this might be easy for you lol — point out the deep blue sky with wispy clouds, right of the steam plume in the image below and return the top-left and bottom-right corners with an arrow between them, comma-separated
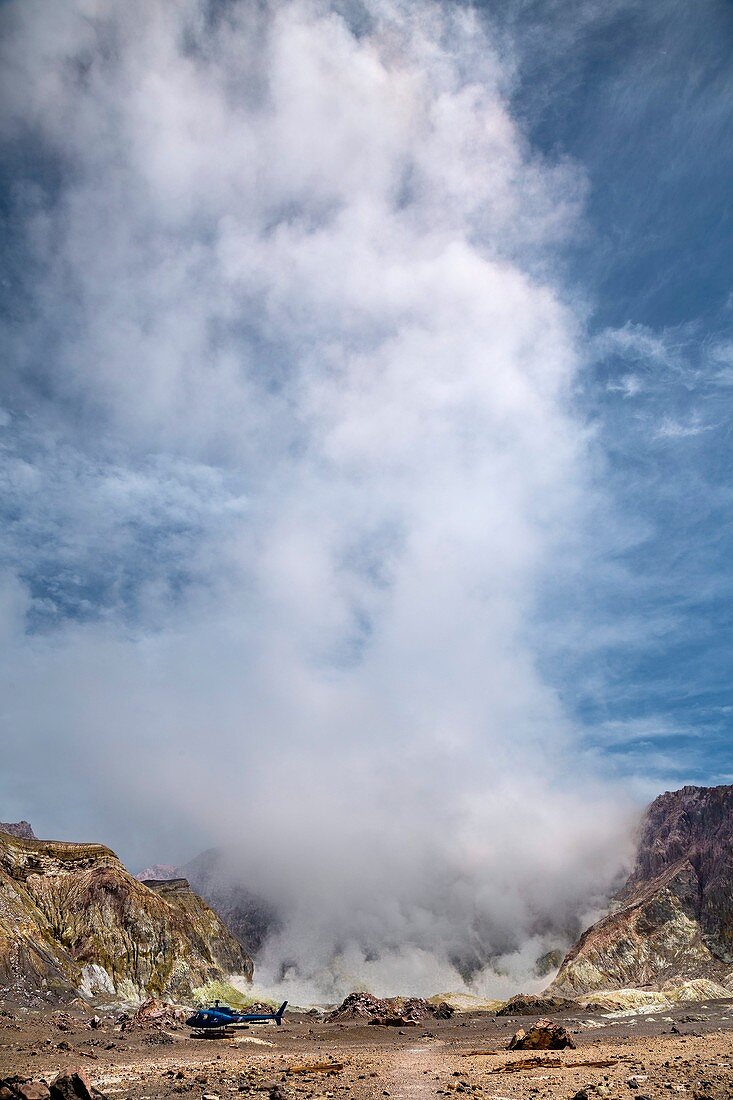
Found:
484,2 -> 733,782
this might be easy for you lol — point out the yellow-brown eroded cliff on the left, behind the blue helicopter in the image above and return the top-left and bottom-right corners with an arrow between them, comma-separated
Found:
0,834 -> 252,1000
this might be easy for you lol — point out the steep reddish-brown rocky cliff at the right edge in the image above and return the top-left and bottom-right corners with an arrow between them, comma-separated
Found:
549,787 -> 733,997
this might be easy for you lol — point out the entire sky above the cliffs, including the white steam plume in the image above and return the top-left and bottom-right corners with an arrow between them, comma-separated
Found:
0,0 -> 733,994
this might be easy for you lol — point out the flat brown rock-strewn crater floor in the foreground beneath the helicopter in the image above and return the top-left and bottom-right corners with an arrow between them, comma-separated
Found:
0,1001 -> 733,1100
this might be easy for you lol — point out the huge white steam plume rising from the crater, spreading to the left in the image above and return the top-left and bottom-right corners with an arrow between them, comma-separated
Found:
2,0 -> 626,997
